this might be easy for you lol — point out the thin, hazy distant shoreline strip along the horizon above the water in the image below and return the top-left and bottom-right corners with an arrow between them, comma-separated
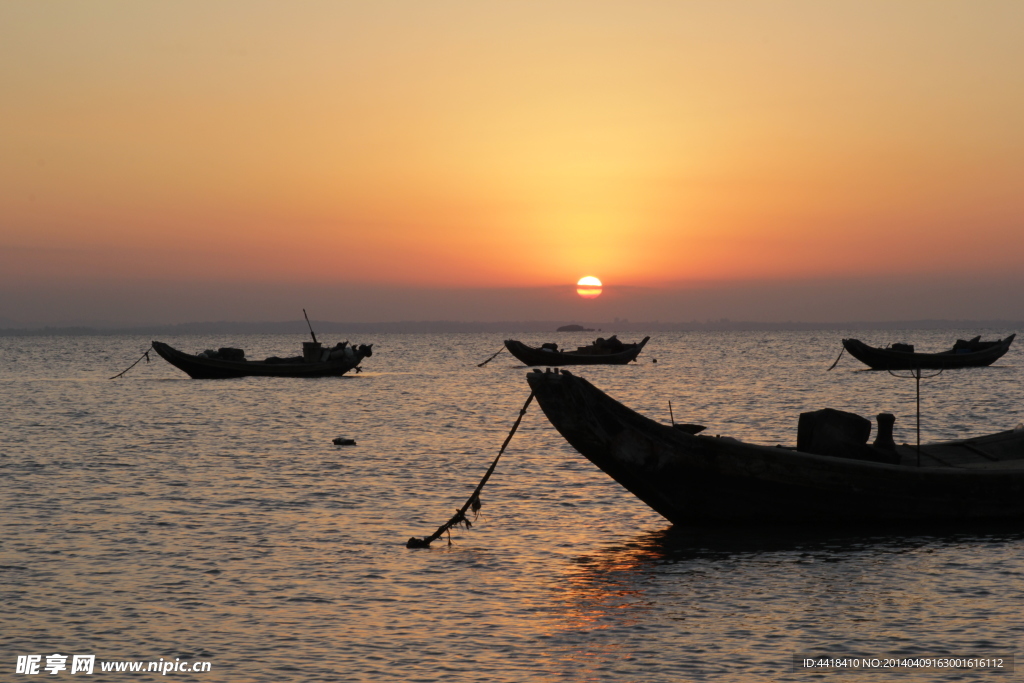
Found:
0,319 -> 1024,337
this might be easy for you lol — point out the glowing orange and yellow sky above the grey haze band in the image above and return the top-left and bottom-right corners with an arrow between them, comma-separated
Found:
0,0 -> 1024,323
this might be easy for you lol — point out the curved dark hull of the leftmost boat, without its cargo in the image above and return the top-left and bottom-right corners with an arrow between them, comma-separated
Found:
153,341 -> 366,380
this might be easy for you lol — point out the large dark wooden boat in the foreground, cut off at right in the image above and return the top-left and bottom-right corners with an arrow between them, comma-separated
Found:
527,370 -> 1024,524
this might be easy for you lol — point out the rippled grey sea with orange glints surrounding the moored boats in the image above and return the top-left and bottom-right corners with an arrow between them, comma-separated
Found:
0,330 -> 1024,682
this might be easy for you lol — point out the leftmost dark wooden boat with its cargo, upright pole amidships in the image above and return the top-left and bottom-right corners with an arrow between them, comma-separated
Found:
153,341 -> 373,380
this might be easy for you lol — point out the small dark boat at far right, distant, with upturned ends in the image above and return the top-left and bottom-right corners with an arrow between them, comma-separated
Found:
843,334 -> 1017,370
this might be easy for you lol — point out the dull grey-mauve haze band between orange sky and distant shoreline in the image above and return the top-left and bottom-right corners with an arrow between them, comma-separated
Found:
0,280 -> 1024,329
